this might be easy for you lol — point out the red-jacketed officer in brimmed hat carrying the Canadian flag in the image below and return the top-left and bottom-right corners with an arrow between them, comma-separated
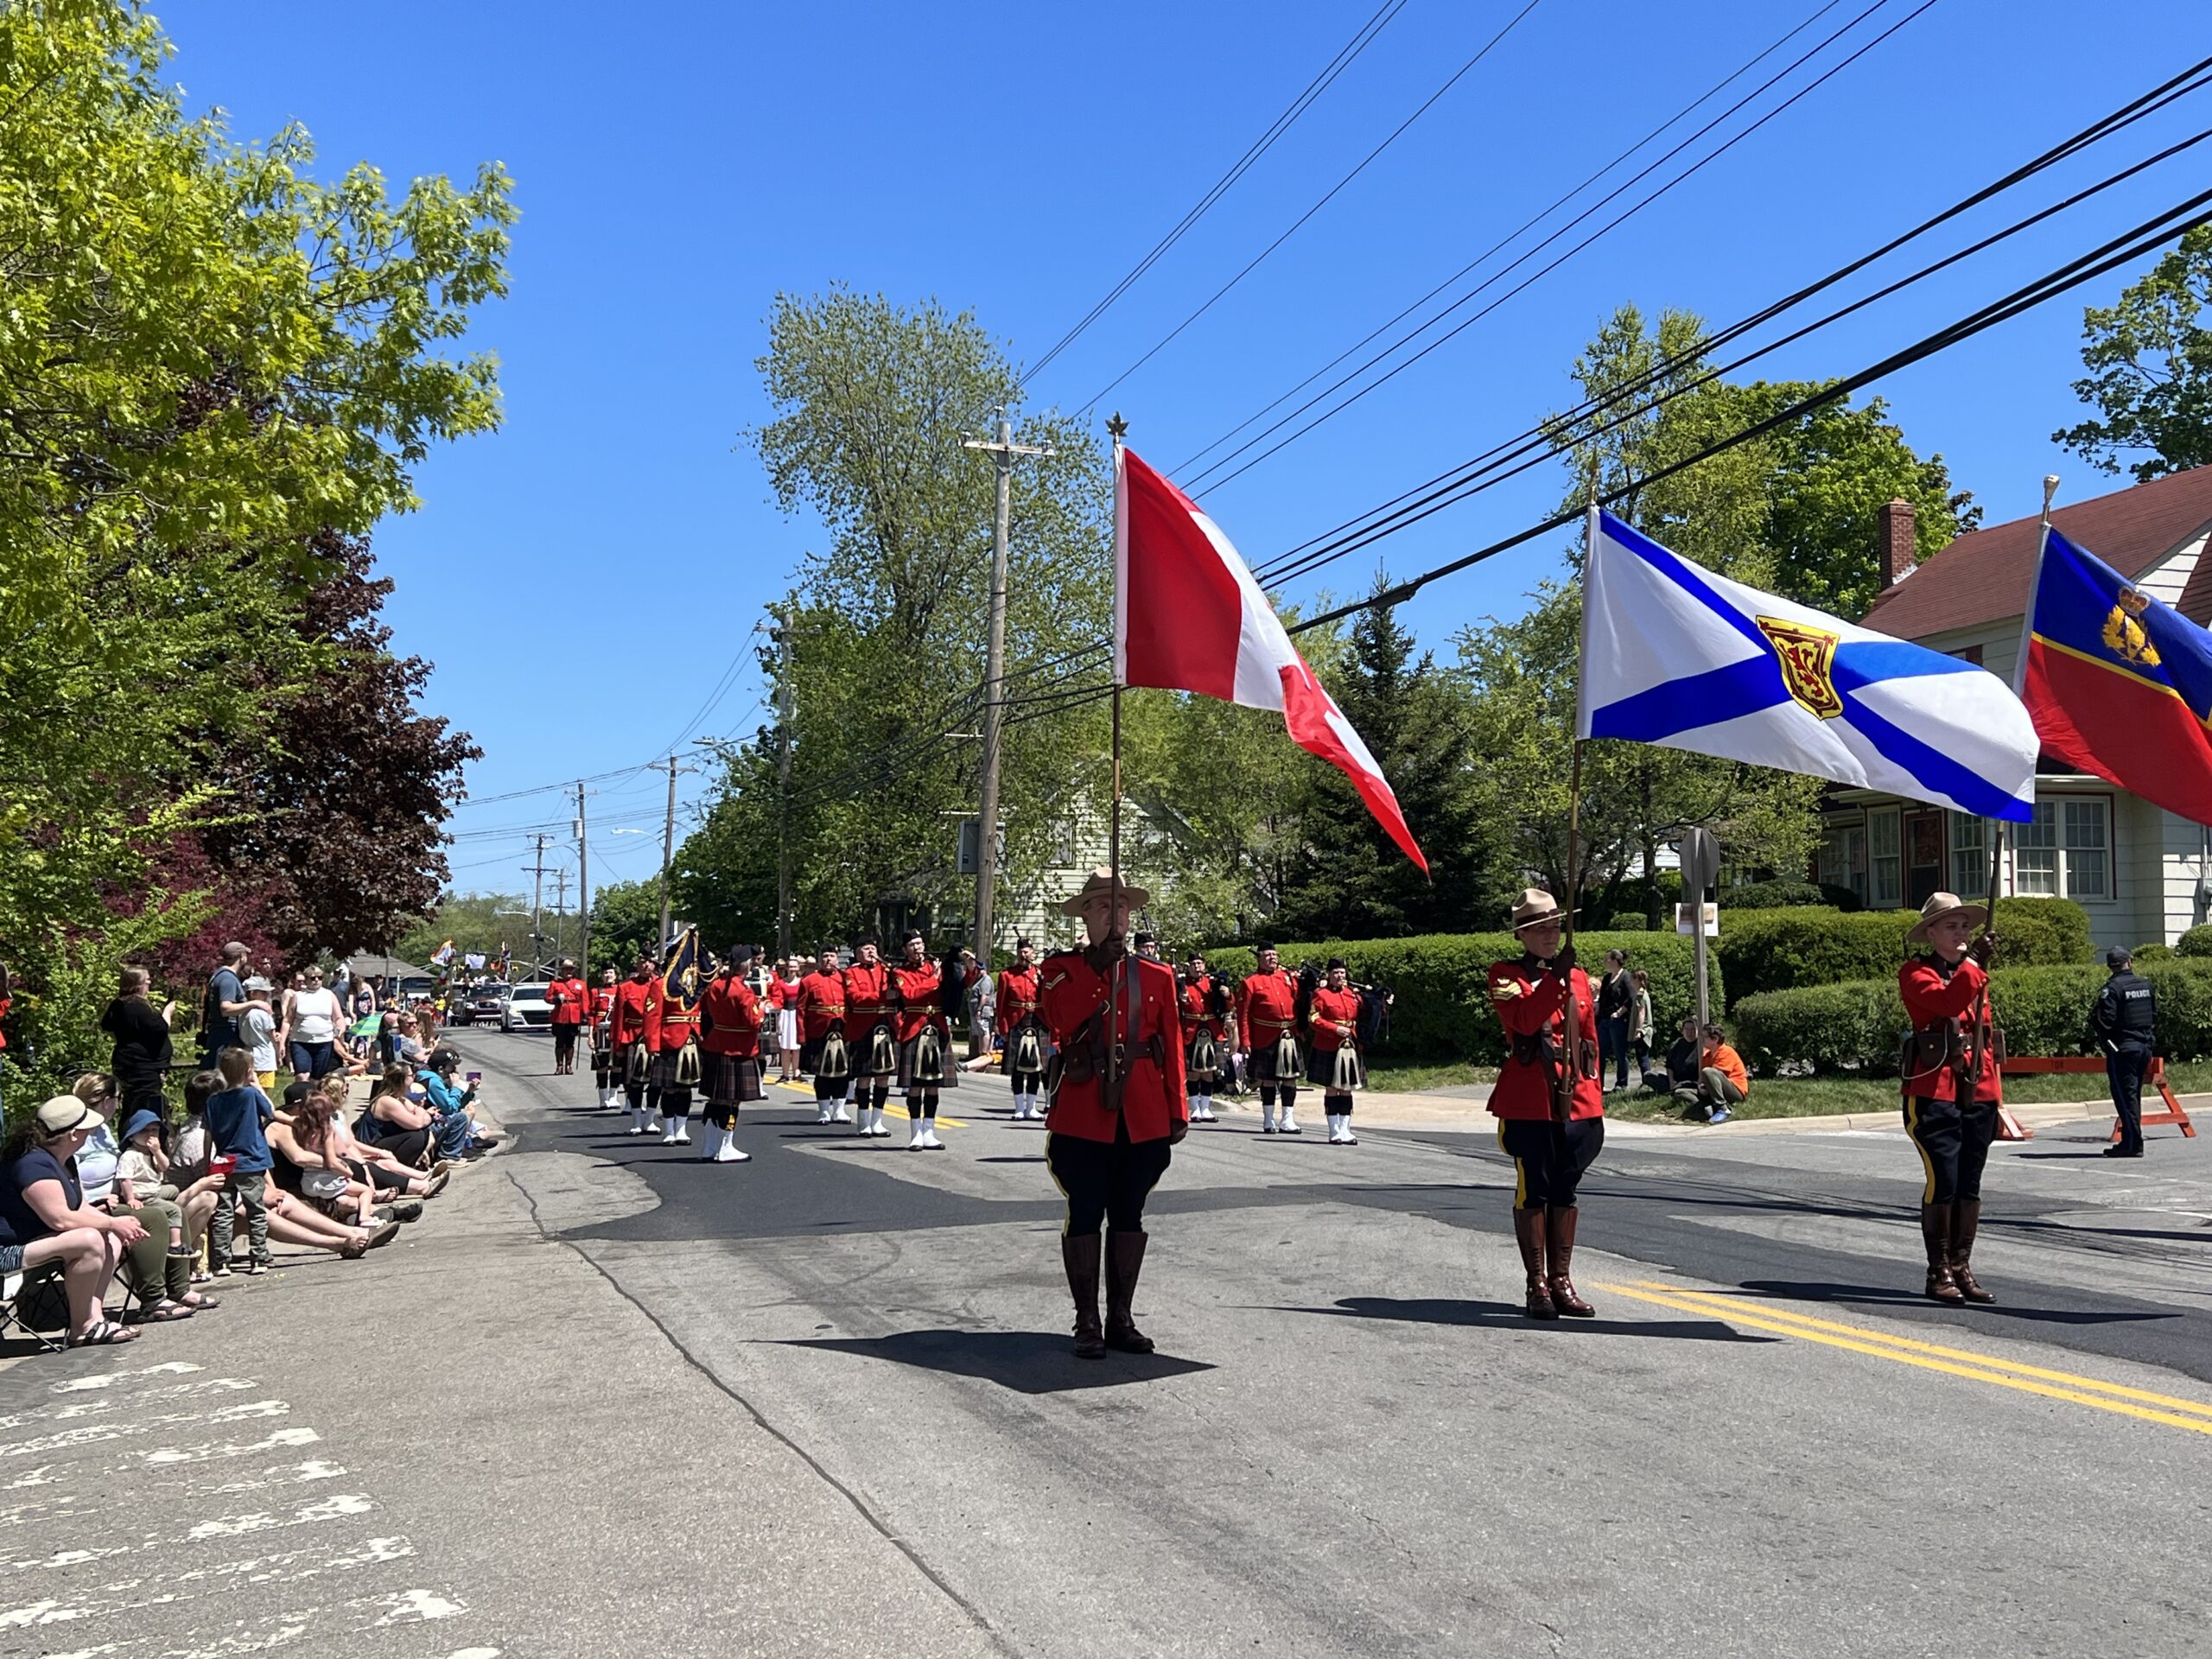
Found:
1038,869 -> 1190,1360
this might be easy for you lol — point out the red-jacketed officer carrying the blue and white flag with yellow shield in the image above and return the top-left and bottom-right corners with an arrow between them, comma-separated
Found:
1491,887 -> 1606,1319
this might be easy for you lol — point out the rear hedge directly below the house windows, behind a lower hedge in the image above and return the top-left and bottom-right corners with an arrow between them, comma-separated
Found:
1717,898 -> 2090,1002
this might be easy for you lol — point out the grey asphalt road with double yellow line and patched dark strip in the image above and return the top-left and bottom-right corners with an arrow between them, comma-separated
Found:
17,1033 -> 2212,1659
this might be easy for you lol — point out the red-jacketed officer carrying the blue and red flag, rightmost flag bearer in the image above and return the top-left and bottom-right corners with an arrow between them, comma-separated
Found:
1897,893 -> 2004,1305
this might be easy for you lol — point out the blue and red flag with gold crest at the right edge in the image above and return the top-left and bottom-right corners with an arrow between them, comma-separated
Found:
2018,529 -> 2212,823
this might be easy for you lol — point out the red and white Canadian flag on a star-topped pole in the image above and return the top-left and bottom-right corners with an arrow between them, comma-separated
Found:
1113,449 -> 1429,874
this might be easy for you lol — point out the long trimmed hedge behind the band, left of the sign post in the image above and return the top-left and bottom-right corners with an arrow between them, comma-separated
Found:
1205,931 -> 1723,1066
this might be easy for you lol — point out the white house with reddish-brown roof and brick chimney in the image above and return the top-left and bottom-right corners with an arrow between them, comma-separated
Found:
1814,467 -> 2212,944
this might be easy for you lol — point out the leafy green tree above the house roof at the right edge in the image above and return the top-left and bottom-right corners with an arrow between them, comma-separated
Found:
2050,226 -> 2212,485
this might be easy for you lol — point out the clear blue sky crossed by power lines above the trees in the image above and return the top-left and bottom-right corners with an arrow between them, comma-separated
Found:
157,0 -> 2212,892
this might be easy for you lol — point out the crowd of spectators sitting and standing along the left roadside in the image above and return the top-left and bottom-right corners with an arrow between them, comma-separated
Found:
0,944 -> 498,1347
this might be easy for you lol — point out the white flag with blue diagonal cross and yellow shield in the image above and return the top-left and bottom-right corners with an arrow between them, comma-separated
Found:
1577,509 -> 2037,823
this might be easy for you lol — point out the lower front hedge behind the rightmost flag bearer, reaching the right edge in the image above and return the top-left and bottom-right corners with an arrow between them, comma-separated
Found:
1734,960 -> 2212,1077
